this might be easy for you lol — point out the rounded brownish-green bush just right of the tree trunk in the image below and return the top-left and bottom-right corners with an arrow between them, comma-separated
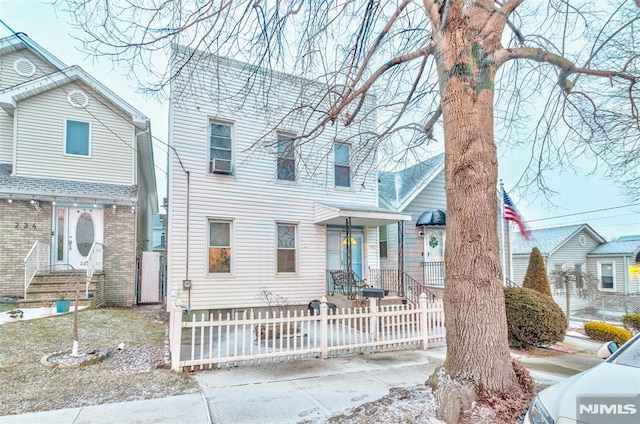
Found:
504,287 -> 567,348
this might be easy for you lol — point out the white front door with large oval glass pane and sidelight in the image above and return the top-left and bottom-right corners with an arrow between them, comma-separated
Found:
52,206 -> 103,269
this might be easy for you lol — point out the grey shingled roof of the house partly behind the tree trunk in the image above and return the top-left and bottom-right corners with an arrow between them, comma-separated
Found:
378,153 -> 444,210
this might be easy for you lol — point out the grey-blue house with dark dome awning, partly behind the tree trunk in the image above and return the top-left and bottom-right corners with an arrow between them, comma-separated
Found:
378,154 -> 518,286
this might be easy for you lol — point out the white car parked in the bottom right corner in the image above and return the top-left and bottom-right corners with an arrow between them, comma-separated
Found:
524,334 -> 640,424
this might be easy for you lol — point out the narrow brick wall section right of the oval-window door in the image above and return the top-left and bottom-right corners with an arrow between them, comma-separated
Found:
102,207 -> 136,306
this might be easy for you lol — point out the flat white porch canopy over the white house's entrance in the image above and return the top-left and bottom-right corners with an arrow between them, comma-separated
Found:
315,203 -> 411,227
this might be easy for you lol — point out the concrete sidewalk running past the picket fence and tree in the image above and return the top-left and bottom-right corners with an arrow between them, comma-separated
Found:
0,337 -> 602,424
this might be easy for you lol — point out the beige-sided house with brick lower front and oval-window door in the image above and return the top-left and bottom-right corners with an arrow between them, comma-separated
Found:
0,34 -> 158,306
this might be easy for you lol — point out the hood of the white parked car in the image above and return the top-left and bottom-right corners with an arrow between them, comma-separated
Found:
538,362 -> 640,419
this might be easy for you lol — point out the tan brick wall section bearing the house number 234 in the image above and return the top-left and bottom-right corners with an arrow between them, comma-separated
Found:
0,199 -> 52,297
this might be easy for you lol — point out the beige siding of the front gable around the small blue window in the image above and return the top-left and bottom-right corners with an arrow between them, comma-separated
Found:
14,84 -> 135,184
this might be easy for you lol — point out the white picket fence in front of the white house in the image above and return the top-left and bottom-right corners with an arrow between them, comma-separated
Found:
170,294 -> 445,371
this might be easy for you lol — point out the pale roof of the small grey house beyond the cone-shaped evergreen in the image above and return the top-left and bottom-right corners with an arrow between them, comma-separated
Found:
511,224 -> 605,256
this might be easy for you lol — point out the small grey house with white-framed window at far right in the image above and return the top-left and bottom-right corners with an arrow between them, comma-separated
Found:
512,224 -> 640,309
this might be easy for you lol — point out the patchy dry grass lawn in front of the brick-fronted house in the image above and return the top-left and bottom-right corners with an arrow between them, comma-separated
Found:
0,305 -> 197,415
